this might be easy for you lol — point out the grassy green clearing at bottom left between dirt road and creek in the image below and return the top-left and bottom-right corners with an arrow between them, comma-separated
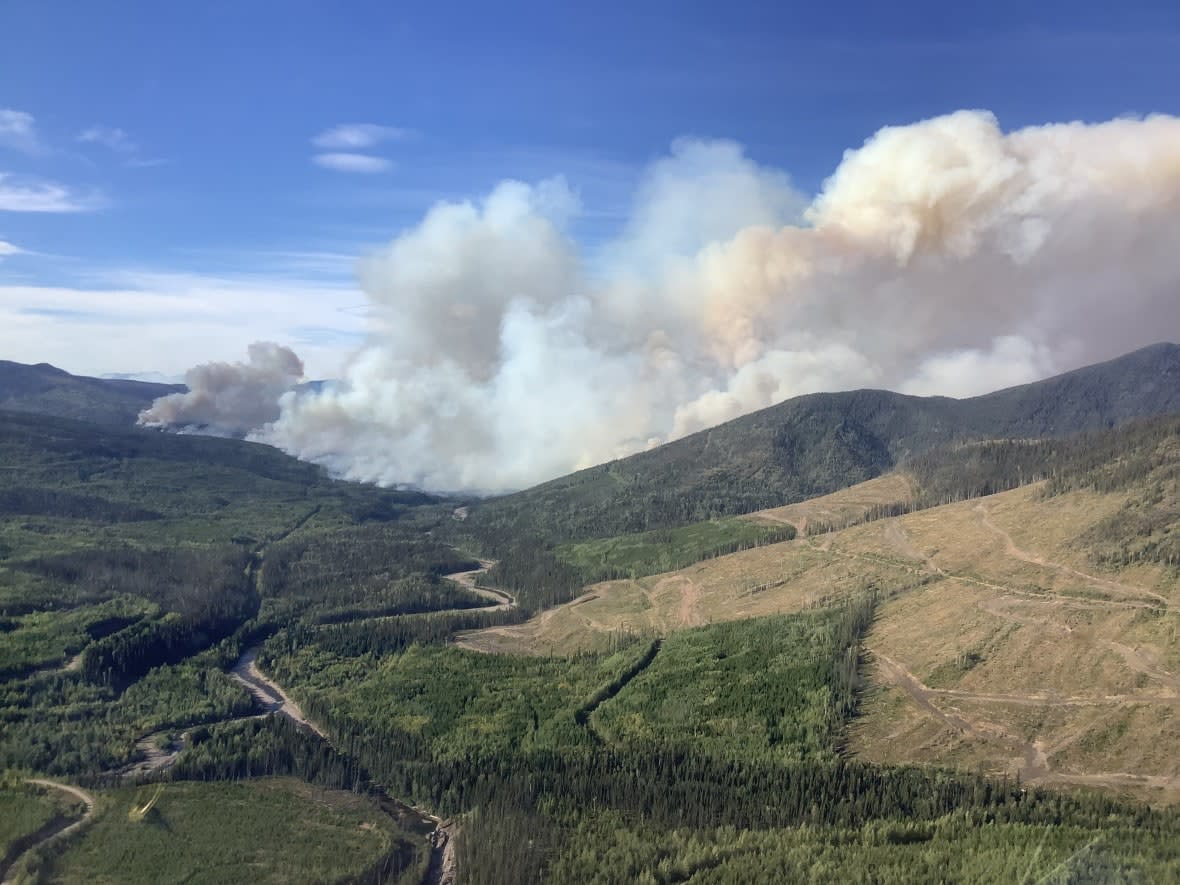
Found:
44,780 -> 425,885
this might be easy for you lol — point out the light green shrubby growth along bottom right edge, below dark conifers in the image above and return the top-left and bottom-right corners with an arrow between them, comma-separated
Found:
548,812 -> 1180,885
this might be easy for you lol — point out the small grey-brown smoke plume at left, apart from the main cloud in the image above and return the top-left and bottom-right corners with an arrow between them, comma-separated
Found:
139,341 -> 303,437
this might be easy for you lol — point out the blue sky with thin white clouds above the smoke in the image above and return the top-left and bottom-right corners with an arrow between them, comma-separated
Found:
0,0 -> 1180,374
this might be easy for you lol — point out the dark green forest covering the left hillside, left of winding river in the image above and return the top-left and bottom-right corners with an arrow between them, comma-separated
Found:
0,413 -> 469,778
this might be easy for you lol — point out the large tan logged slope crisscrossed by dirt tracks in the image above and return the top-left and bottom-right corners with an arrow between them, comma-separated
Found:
463,480 -> 1180,801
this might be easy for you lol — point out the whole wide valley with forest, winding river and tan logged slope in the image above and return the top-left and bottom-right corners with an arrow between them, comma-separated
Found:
0,349 -> 1180,885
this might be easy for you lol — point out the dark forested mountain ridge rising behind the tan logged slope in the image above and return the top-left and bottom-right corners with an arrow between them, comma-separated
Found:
467,343 -> 1180,545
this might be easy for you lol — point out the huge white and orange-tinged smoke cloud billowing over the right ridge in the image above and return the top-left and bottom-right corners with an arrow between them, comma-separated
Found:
153,111 -> 1180,491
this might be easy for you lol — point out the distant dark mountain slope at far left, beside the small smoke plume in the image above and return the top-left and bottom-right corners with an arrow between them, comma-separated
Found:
0,360 -> 185,427
